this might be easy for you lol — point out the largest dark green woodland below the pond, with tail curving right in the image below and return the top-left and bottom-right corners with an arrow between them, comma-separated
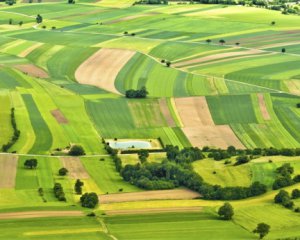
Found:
120,145 -> 267,200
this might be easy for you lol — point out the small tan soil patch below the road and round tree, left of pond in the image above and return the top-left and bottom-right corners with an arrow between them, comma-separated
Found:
60,157 -> 90,179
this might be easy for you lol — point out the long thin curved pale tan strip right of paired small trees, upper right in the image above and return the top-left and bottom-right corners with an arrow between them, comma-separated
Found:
173,49 -> 263,67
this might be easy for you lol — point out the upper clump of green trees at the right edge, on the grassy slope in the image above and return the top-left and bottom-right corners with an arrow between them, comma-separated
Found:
272,163 -> 300,190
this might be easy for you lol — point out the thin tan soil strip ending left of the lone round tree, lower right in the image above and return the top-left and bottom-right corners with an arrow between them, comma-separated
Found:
105,207 -> 202,215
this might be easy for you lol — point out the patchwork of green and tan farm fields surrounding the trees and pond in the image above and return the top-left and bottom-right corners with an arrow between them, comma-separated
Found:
0,0 -> 300,240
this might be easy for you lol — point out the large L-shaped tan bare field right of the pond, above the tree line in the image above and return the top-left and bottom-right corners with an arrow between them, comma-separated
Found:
175,97 -> 245,149
